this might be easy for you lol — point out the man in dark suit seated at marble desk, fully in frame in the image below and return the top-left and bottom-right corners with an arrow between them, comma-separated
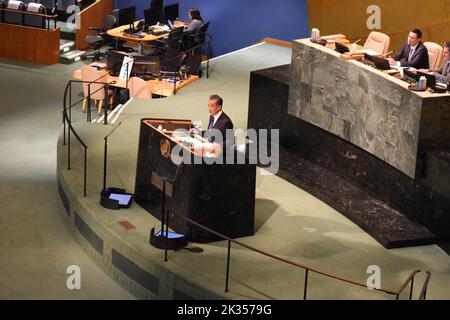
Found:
389,29 -> 430,69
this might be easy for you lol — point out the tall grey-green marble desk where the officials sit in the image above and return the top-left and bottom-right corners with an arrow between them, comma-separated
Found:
288,39 -> 450,179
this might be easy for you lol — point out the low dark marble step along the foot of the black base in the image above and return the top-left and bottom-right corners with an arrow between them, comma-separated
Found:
277,147 -> 437,249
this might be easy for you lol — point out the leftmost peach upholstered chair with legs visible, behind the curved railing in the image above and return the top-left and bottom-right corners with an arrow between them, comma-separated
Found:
81,66 -> 113,114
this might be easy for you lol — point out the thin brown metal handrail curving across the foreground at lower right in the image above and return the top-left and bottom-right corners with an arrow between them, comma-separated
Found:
166,213 -> 421,300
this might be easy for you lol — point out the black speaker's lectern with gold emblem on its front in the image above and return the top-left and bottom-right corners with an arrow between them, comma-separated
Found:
134,119 -> 256,242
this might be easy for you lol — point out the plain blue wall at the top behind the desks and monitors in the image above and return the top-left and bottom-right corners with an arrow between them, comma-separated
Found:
116,0 -> 309,56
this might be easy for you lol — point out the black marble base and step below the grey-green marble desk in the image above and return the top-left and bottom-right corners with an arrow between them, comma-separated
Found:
248,65 -> 450,248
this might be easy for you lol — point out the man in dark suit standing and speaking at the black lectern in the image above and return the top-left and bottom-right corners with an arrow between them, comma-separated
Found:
191,94 -> 233,146
